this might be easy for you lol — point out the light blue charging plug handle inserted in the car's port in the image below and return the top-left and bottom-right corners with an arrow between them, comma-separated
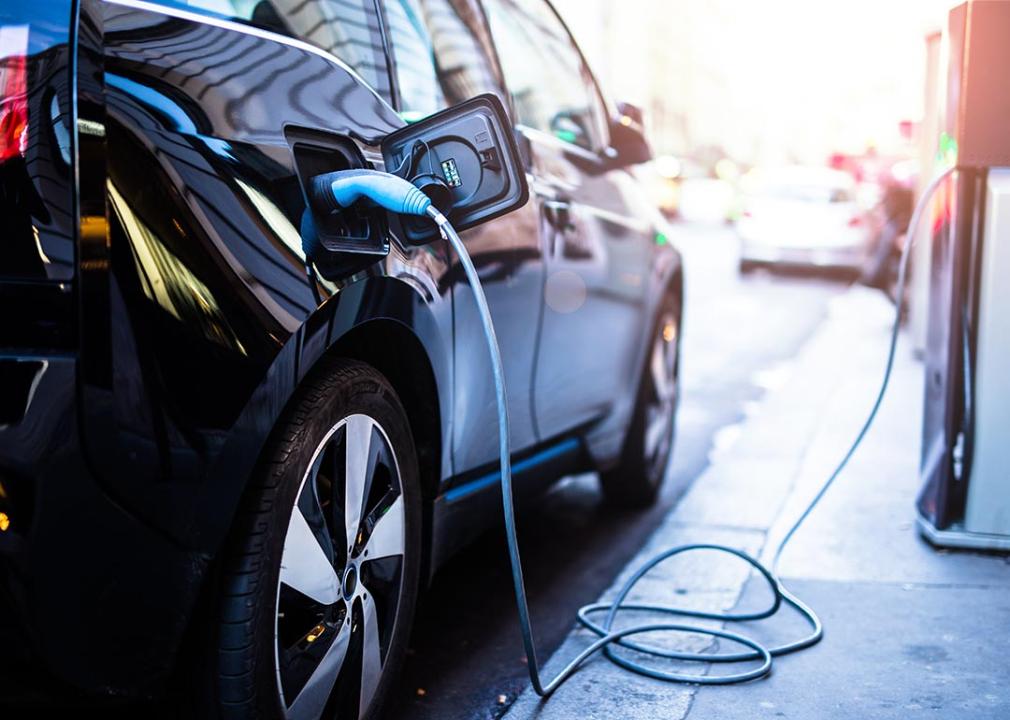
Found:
309,170 -> 431,215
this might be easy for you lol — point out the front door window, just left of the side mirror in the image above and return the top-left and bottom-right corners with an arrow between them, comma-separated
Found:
484,0 -> 605,149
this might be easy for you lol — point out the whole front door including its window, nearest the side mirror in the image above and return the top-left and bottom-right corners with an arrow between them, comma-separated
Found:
484,0 -> 654,456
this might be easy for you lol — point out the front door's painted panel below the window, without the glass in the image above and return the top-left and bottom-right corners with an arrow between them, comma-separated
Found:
524,129 -> 655,458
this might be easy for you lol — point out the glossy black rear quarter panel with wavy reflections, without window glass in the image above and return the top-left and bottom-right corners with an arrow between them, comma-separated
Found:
85,4 -> 446,548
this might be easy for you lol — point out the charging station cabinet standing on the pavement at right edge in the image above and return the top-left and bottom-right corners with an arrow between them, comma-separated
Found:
917,0 -> 1010,550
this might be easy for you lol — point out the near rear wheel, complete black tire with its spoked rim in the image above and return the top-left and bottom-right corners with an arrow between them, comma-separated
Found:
208,359 -> 421,720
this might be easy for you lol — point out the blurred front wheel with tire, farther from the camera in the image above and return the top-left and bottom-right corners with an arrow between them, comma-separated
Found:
600,294 -> 681,508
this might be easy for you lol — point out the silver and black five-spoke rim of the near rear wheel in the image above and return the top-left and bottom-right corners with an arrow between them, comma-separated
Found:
275,414 -> 405,720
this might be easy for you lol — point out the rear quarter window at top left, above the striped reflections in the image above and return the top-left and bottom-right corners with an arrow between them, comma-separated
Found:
160,0 -> 392,102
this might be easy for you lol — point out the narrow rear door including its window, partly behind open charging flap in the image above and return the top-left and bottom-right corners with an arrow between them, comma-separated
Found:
377,0 -> 544,482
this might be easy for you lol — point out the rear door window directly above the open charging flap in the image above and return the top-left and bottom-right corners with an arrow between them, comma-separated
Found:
384,0 -> 504,120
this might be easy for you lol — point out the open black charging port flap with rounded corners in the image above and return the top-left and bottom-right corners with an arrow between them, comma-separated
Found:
382,94 -> 529,245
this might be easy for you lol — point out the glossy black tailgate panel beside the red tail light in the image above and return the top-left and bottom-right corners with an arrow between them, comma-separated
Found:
0,0 -> 77,355
